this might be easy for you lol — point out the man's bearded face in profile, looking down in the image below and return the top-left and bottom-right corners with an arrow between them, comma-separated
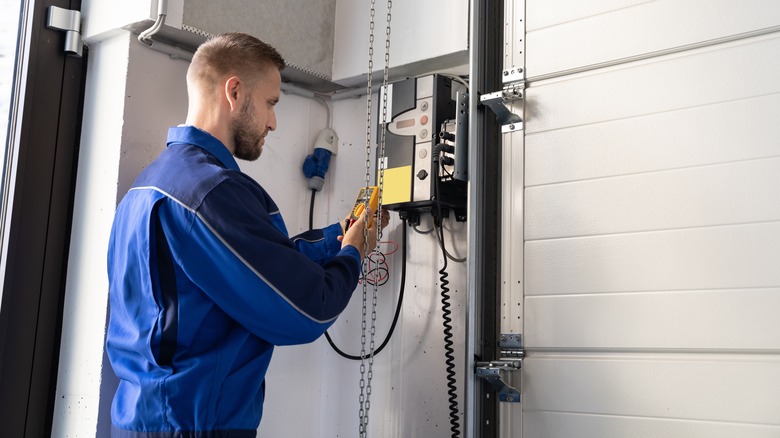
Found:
232,68 -> 282,161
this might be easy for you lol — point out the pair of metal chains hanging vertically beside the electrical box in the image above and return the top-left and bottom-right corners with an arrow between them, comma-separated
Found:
359,0 -> 393,438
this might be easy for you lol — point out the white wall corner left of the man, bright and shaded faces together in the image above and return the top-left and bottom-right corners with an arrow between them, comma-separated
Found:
54,31 -> 192,436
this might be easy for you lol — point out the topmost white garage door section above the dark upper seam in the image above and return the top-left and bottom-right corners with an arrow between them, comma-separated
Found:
526,0 -> 780,80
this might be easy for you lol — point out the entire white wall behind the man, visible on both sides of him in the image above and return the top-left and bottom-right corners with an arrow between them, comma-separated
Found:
53,1 -> 466,437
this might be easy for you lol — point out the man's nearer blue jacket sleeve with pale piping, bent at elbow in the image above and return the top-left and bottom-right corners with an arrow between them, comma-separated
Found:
160,180 -> 360,345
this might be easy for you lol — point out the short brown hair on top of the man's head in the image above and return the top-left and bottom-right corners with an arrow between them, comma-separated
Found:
187,32 -> 285,91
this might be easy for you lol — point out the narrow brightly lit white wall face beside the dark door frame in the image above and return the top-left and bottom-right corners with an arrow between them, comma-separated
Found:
52,35 -> 129,436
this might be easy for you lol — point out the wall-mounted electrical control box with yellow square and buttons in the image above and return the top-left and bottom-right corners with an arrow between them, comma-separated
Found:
377,75 -> 468,220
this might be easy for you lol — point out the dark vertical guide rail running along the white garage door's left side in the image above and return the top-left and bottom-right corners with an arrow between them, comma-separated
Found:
464,0 -> 502,437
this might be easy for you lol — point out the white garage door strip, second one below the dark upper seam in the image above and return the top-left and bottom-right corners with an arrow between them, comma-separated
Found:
525,93 -> 780,187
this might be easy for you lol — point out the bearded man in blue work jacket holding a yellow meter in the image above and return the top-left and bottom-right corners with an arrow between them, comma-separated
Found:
106,33 -> 386,438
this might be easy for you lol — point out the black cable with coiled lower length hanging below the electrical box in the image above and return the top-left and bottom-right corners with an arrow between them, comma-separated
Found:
431,144 -> 460,438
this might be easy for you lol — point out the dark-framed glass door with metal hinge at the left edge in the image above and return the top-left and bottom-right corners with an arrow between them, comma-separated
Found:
0,0 -> 87,437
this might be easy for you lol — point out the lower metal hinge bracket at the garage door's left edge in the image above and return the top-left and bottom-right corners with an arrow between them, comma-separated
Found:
475,333 -> 525,403
